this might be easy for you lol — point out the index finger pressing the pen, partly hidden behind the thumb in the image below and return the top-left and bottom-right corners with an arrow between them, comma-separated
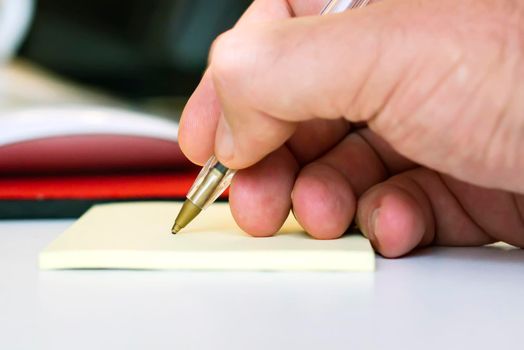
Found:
178,0 -> 327,164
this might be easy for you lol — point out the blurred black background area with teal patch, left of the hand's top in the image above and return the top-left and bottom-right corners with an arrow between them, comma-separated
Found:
20,0 -> 251,98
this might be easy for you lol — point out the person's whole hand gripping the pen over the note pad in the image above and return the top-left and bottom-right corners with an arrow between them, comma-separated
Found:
179,0 -> 524,257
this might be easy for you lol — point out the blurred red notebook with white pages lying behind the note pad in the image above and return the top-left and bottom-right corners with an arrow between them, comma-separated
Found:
0,107 -> 209,219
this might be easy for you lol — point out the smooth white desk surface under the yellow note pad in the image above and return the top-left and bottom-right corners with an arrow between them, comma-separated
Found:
0,220 -> 524,350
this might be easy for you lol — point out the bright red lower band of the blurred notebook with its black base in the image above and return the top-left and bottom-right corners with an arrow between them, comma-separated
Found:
0,171 -> 207,219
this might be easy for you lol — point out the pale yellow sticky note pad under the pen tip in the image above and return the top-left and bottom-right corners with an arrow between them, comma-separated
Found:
39,202 -> 375,271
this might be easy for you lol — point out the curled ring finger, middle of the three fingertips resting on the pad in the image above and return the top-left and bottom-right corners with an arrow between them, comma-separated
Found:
292,129 -> 412,239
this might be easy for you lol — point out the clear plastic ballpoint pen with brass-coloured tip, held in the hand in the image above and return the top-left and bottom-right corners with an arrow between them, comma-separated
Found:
171,0 -> 372,234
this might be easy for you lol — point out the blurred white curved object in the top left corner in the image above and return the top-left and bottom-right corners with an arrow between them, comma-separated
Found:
0,0 -> 34,63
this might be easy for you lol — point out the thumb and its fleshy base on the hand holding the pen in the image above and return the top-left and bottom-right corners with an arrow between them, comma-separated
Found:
210,0 -> 524,191
